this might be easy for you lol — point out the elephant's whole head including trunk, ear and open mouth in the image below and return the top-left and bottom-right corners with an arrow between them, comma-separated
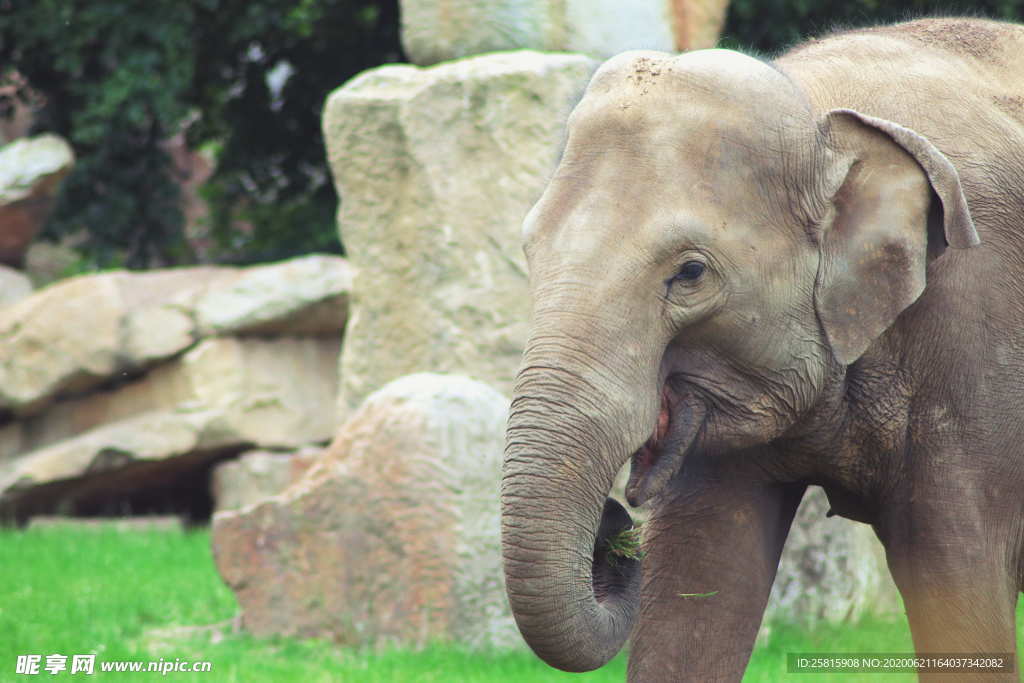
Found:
502,50 -> 978,671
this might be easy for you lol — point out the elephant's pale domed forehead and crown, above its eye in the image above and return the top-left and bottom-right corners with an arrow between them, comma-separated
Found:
523,50 -> 816,258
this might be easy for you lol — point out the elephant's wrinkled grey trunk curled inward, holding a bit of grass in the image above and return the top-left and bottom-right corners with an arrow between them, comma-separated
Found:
502,335 -> 657,672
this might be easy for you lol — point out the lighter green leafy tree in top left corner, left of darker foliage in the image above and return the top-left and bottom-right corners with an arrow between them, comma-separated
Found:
0,0 -> 194,265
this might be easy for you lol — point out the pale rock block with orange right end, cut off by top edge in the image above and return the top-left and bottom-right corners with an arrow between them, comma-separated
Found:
401,0 -> 728,65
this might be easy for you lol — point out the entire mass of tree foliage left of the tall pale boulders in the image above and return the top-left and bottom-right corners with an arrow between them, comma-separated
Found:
0,0 -> 400,267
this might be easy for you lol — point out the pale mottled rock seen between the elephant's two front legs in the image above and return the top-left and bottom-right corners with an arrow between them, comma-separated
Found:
764,486 -> 902,626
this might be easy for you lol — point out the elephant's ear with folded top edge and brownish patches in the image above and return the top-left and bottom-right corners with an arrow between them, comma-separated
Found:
814,110 -> 980,365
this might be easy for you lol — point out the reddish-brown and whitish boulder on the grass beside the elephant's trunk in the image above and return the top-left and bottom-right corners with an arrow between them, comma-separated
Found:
213,374 -> 521,647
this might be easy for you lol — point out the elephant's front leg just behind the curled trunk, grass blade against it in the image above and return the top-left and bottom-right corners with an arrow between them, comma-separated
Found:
629,462 -> 805,682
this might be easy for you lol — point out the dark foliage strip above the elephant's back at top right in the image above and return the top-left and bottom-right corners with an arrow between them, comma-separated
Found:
723,0 -> 1024,54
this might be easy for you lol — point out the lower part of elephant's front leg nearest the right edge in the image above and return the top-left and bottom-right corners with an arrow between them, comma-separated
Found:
879,490 -> 1019,681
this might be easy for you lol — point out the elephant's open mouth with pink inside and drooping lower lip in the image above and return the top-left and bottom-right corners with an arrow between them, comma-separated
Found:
626,383 -> 707,507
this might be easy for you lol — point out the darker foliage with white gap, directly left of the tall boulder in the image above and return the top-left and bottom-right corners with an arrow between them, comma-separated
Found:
188,0 -> 402,260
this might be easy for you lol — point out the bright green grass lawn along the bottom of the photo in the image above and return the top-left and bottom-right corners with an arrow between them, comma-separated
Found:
0,527 -> 1022,683
